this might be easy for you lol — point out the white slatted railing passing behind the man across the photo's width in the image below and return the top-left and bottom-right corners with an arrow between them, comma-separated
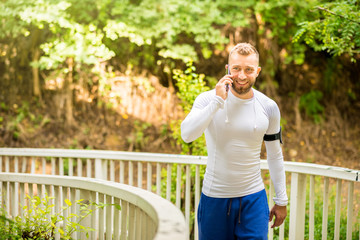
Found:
0,148 -> 360,240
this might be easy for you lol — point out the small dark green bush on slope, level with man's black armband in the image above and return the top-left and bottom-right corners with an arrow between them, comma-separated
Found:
299,90 -> 324,123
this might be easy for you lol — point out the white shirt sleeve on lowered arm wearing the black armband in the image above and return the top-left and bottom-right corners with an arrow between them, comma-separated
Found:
265,102 -> 288,206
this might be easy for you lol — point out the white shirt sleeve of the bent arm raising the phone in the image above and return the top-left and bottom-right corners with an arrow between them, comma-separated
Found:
181,90 -> 225,143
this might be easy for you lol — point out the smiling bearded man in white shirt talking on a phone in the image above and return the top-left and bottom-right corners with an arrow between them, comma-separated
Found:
181,43 -> 288,240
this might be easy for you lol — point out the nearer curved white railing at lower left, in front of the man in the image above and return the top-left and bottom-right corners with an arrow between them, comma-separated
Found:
0,173 -> 188,240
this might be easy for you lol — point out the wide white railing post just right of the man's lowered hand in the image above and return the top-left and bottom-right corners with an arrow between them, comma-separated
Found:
289,173 -> 306,240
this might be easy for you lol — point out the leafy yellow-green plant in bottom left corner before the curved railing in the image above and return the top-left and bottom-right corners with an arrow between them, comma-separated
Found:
0,195 -> 116,239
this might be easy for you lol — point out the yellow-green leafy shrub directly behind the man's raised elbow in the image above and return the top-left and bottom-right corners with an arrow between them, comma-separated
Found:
170,61 -> 209,155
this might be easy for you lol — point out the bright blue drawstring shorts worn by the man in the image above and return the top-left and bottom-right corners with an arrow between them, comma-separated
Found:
198,189 -> 269,240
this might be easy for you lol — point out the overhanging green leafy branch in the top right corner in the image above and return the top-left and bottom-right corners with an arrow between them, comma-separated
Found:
293,0 -> 360,62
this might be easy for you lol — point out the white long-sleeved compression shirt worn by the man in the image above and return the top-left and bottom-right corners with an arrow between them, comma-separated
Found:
181,89 -> 288,206
